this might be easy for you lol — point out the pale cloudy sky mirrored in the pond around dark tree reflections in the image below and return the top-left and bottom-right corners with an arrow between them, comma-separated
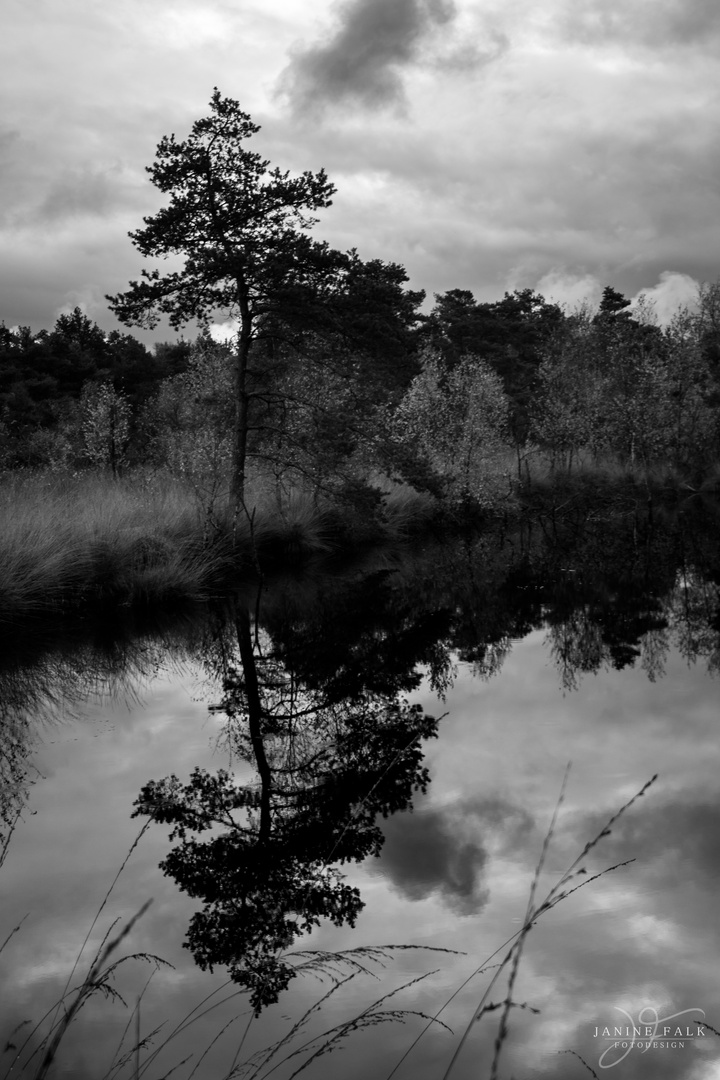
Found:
0,632 -> 720,1080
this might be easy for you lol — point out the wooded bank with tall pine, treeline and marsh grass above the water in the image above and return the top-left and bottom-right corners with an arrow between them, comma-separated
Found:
0,91 -> 720,616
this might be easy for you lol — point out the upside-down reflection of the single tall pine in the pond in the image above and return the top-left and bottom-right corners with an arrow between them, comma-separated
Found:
135,609 -> 437,1012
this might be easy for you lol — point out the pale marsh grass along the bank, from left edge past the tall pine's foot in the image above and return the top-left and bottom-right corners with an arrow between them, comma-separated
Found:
0,471 -> 444,624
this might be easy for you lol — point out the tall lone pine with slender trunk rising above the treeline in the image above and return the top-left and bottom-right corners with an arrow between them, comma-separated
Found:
108,87 -> 335,513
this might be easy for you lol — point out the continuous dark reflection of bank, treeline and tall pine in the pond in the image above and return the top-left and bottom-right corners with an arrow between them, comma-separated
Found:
0,491 -> 720,989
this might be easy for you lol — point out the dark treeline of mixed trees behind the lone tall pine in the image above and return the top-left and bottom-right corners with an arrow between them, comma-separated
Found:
0,276 -> 720,501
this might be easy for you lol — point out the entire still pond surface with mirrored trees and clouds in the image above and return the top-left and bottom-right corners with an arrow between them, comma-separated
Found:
0,498 -> 720,1080
